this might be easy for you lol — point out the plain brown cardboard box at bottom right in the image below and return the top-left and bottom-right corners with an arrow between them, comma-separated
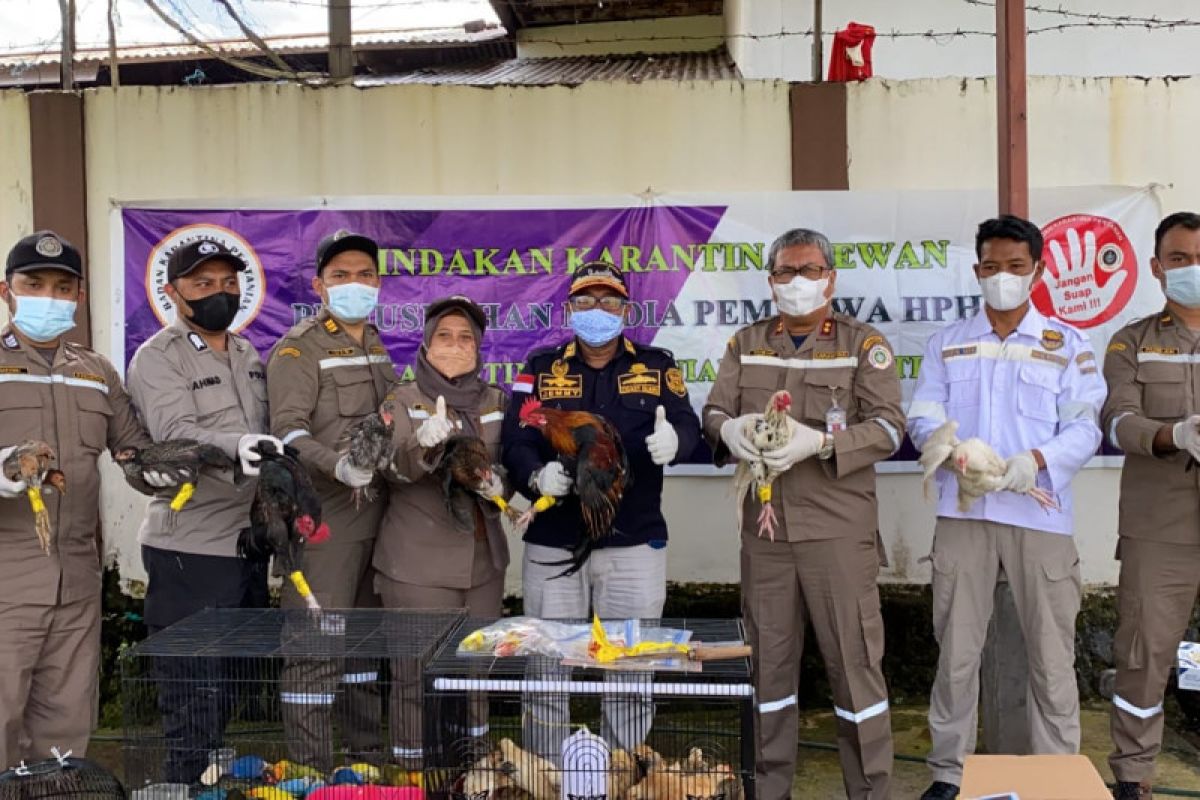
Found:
960,756 -> 1112,800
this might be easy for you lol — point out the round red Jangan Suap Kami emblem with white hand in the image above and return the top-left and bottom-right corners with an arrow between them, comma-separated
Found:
1033,213 -> 1138,327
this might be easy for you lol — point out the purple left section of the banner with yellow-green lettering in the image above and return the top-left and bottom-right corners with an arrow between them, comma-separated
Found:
121,206 -> 725,385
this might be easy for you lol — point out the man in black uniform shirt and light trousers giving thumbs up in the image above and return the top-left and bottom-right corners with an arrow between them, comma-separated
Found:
503,261 -> 701,758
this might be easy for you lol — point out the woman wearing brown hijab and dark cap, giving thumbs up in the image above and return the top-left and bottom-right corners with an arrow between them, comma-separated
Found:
373,295 -> 509,768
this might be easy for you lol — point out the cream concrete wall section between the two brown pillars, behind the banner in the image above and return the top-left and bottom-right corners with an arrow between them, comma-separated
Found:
85,82 -> 791,594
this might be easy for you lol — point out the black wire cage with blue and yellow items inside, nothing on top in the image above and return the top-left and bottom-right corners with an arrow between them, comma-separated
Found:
121,609 -> 463,800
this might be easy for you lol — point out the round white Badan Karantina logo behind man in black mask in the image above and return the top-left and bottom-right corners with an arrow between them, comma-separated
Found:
146,224 -> 266,333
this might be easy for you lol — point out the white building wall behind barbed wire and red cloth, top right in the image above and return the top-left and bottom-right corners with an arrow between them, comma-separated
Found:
725,0 -> 1200,80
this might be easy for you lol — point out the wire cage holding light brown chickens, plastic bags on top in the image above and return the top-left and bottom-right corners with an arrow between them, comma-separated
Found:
424,619 -> 755,800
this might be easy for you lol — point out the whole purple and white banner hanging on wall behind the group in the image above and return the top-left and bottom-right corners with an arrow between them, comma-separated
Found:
113,187 -> 1163,462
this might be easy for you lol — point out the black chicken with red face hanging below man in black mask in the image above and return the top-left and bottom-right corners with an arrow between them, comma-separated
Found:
238,441 -> 329,610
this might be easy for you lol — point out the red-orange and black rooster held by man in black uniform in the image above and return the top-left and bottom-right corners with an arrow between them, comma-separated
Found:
517,397 -> 630,577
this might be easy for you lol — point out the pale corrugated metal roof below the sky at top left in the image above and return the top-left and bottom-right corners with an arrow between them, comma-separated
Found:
0,26 -> 506,70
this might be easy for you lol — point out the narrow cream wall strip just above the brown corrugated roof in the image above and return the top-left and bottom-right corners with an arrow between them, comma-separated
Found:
517,16 -> 725,59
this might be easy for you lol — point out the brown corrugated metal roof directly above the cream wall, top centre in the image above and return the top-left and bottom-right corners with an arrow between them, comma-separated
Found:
354,47 -> 742,86
